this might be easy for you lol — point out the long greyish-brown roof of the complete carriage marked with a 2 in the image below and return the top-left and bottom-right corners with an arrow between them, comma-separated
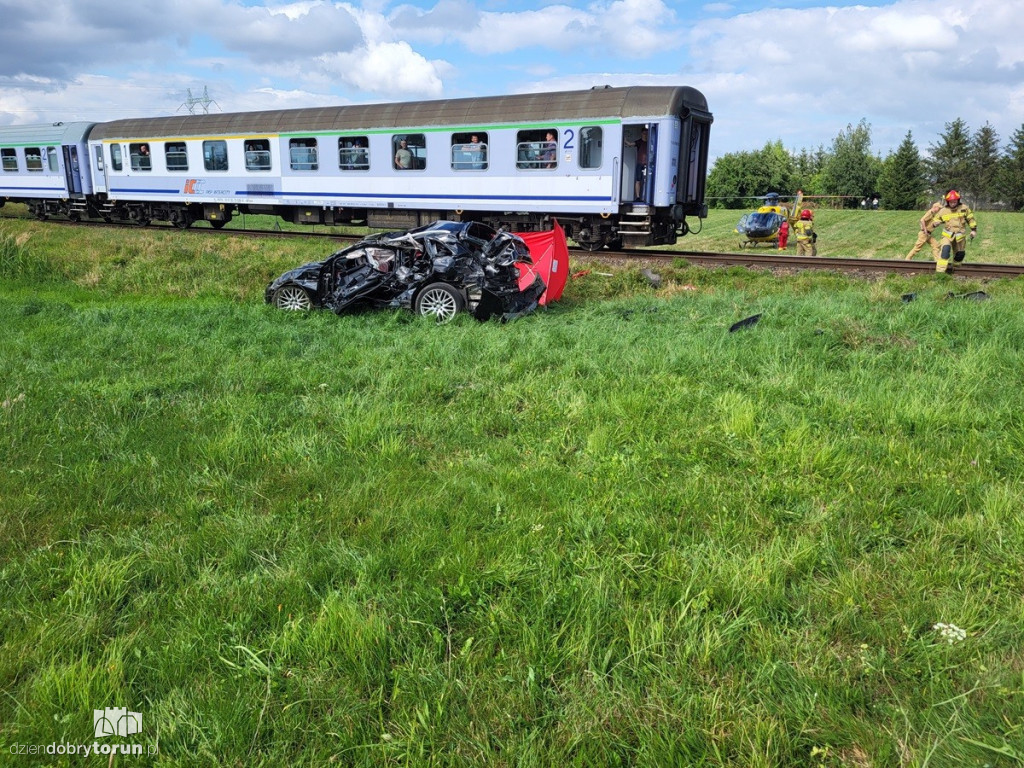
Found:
90,86 -> 708,139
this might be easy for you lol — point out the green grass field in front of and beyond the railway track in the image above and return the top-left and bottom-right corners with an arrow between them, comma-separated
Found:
0,211 -> 1024,768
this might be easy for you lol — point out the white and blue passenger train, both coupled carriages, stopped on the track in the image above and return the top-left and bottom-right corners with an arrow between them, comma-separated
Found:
0,86 -> 713,249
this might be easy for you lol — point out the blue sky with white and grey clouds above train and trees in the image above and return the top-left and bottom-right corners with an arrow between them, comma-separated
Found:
0,0 -> 1024,165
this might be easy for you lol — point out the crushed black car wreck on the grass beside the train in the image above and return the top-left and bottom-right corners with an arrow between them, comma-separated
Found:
265,221 -> 545,323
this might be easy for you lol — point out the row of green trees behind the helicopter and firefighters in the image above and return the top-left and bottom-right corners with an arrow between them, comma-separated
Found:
708,118 -> 1024,211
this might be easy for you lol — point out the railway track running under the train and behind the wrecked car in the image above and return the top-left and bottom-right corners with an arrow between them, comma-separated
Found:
4,210 -> 1024,280
